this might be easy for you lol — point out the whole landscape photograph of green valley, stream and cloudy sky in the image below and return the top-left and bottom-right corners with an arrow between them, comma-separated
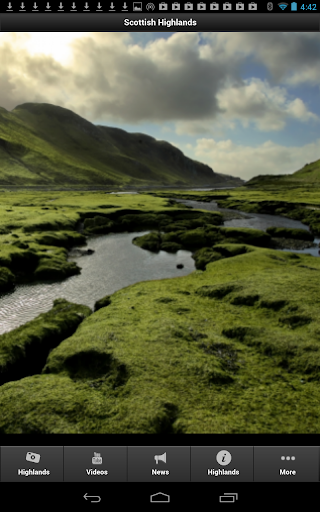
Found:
0,32 -> 320,434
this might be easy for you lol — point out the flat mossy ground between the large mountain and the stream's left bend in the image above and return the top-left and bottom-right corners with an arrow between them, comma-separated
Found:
0,190 -> 198,293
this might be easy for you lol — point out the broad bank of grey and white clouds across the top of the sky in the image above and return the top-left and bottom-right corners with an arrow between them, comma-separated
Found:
0,32 -> 320,133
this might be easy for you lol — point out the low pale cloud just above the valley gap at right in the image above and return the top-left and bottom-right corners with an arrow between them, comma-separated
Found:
188,138 -> 320,180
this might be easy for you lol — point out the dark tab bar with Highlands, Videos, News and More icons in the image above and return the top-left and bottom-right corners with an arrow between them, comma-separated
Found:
0,446 -> 320,482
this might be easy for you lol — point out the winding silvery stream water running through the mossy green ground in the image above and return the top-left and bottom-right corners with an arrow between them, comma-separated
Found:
0,194 -> 320,334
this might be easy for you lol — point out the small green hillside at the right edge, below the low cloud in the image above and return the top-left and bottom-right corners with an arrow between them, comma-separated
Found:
246,159 -> 320,187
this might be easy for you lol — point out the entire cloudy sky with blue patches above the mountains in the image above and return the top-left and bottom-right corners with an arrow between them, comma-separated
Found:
0,32 -> 320,180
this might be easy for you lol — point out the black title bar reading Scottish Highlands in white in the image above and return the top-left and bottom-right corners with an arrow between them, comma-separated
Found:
0,12 -> 320,32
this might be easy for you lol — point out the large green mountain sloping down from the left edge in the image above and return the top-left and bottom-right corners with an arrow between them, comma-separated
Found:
0,103 -> 242,186
